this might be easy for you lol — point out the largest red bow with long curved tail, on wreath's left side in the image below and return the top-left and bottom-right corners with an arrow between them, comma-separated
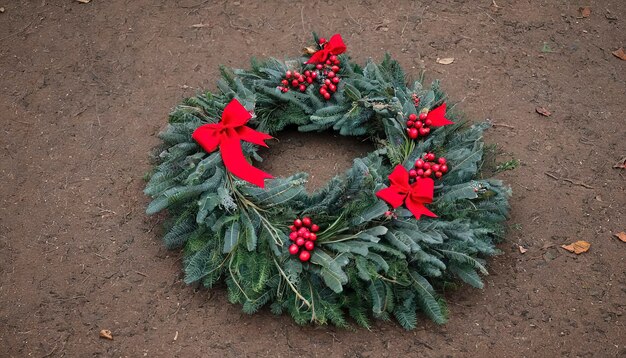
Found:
191,99 -> 273,188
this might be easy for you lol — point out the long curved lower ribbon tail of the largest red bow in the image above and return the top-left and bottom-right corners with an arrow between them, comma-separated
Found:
220,138 -> 273,188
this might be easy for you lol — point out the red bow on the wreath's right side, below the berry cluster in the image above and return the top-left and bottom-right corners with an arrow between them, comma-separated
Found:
376,165 -> 437,219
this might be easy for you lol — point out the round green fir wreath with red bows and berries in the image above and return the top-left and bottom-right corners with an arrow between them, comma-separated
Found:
145,35 -> 510,329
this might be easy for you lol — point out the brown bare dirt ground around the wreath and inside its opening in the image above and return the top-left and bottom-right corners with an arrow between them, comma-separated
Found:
0,0 -> 626,357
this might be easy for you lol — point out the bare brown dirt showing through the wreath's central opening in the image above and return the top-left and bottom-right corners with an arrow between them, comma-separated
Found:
255,129 -> 375,193
